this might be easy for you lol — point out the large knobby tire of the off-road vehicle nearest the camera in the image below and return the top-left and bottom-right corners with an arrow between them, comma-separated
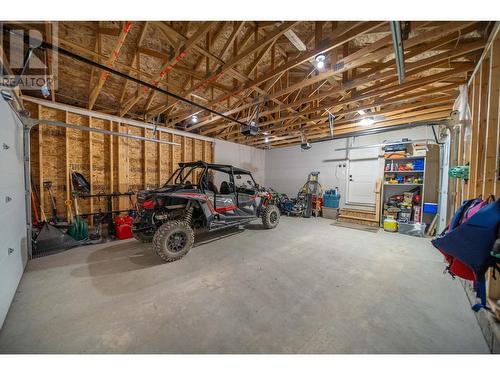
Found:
153,220 -> 194,262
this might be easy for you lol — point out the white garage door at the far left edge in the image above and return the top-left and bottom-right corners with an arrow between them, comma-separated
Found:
0,97 -> 28,327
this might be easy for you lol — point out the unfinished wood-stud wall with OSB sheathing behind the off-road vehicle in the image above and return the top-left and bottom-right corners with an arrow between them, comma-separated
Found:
25,102 -> 213,223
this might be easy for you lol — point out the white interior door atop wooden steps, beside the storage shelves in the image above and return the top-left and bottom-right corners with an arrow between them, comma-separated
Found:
346,159 -> 379,206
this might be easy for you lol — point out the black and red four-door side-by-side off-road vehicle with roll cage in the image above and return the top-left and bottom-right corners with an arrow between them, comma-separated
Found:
132,161 -> 280,262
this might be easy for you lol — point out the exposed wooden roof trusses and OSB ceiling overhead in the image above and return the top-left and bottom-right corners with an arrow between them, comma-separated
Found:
3,21 -> 491,148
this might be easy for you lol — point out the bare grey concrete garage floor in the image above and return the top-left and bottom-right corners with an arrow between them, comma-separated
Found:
0,217 -> 489,353
